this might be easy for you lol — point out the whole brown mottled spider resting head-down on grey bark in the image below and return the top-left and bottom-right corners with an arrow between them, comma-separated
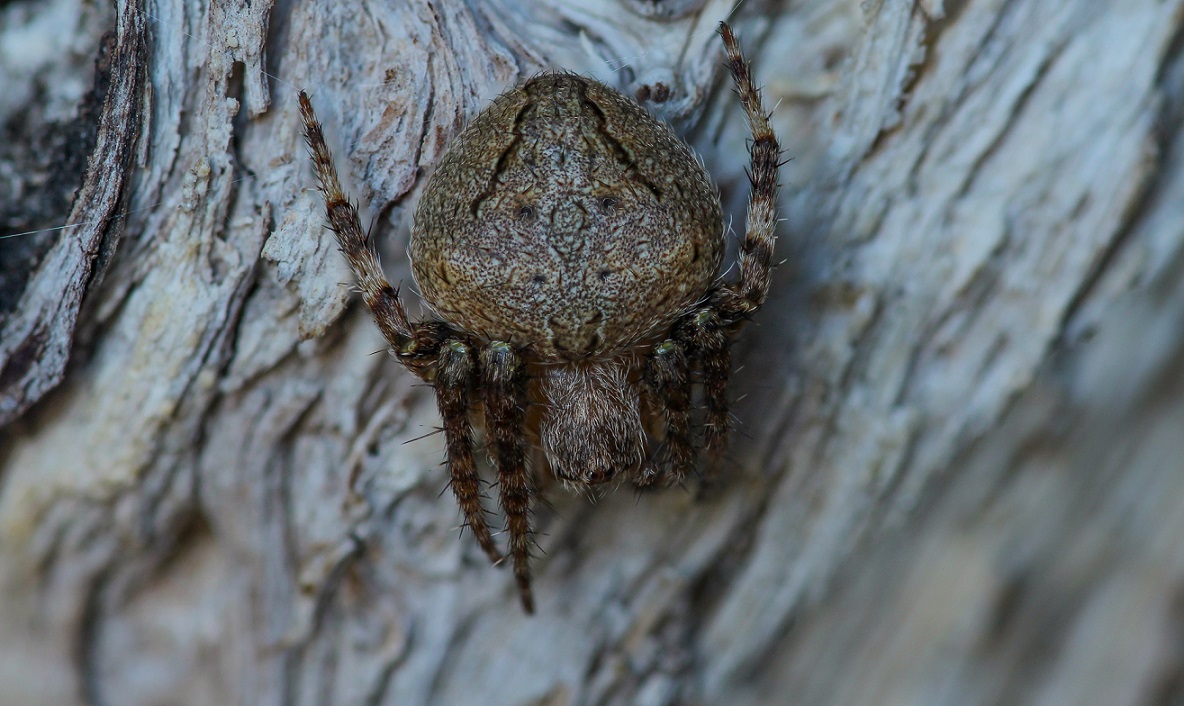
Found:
300,23 -> 780,614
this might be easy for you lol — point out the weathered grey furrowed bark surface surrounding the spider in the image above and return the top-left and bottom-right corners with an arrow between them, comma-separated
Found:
0,0 -> 1184,706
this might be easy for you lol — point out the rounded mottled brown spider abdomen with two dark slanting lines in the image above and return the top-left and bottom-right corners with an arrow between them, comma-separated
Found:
411,73 -> 723,360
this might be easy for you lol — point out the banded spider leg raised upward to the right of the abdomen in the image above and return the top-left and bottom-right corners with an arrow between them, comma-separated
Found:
720,23 -> 780,326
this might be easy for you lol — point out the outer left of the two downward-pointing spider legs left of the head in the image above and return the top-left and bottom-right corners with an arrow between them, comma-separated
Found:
435,339 -> 502,564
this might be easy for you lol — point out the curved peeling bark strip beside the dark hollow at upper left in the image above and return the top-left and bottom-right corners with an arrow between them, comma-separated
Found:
0,0 -> 150,426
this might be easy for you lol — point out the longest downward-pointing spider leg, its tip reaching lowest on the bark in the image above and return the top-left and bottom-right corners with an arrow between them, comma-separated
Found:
481,341 -> 534,614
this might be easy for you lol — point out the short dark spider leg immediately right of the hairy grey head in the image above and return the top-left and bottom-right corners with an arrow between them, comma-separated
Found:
636,339 -> 695,488
